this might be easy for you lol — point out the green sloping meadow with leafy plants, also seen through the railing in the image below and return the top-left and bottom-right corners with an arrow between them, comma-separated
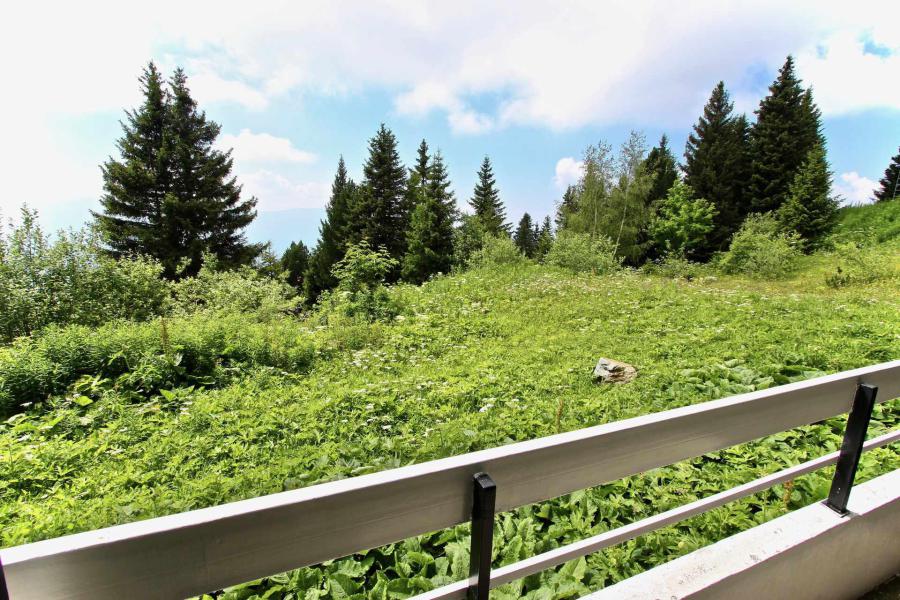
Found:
0,207 -> 900,600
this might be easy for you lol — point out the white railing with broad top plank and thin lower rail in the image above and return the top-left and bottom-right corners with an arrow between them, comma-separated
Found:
0,361 -> 900,600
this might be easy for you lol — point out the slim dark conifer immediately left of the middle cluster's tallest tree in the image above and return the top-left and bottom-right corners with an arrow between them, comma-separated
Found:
303,156 -> 357,303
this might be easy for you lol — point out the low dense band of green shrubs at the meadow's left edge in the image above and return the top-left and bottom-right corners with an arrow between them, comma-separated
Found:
0,314 -> 315,416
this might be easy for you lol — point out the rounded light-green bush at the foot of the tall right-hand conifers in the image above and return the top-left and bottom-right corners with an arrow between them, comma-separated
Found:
716,213 -> 801,279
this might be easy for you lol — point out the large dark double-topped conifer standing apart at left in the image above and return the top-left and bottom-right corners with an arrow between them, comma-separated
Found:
94,63 -> 263,278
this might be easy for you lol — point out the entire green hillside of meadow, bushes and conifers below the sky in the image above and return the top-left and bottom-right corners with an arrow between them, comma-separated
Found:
0,57 -> 900,600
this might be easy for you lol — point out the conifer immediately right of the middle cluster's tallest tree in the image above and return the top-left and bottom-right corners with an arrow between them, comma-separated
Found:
402,151 -> 456,283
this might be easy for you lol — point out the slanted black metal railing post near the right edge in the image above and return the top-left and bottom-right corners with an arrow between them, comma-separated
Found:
825,383 -> 878,515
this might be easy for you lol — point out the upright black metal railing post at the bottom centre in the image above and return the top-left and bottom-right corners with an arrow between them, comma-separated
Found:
467,473 -> 497,600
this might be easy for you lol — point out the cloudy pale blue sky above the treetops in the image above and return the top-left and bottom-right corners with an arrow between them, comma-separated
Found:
0,0 -> 900,250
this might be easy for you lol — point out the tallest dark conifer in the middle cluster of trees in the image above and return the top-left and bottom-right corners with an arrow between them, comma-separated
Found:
351,123 -> 409,264
